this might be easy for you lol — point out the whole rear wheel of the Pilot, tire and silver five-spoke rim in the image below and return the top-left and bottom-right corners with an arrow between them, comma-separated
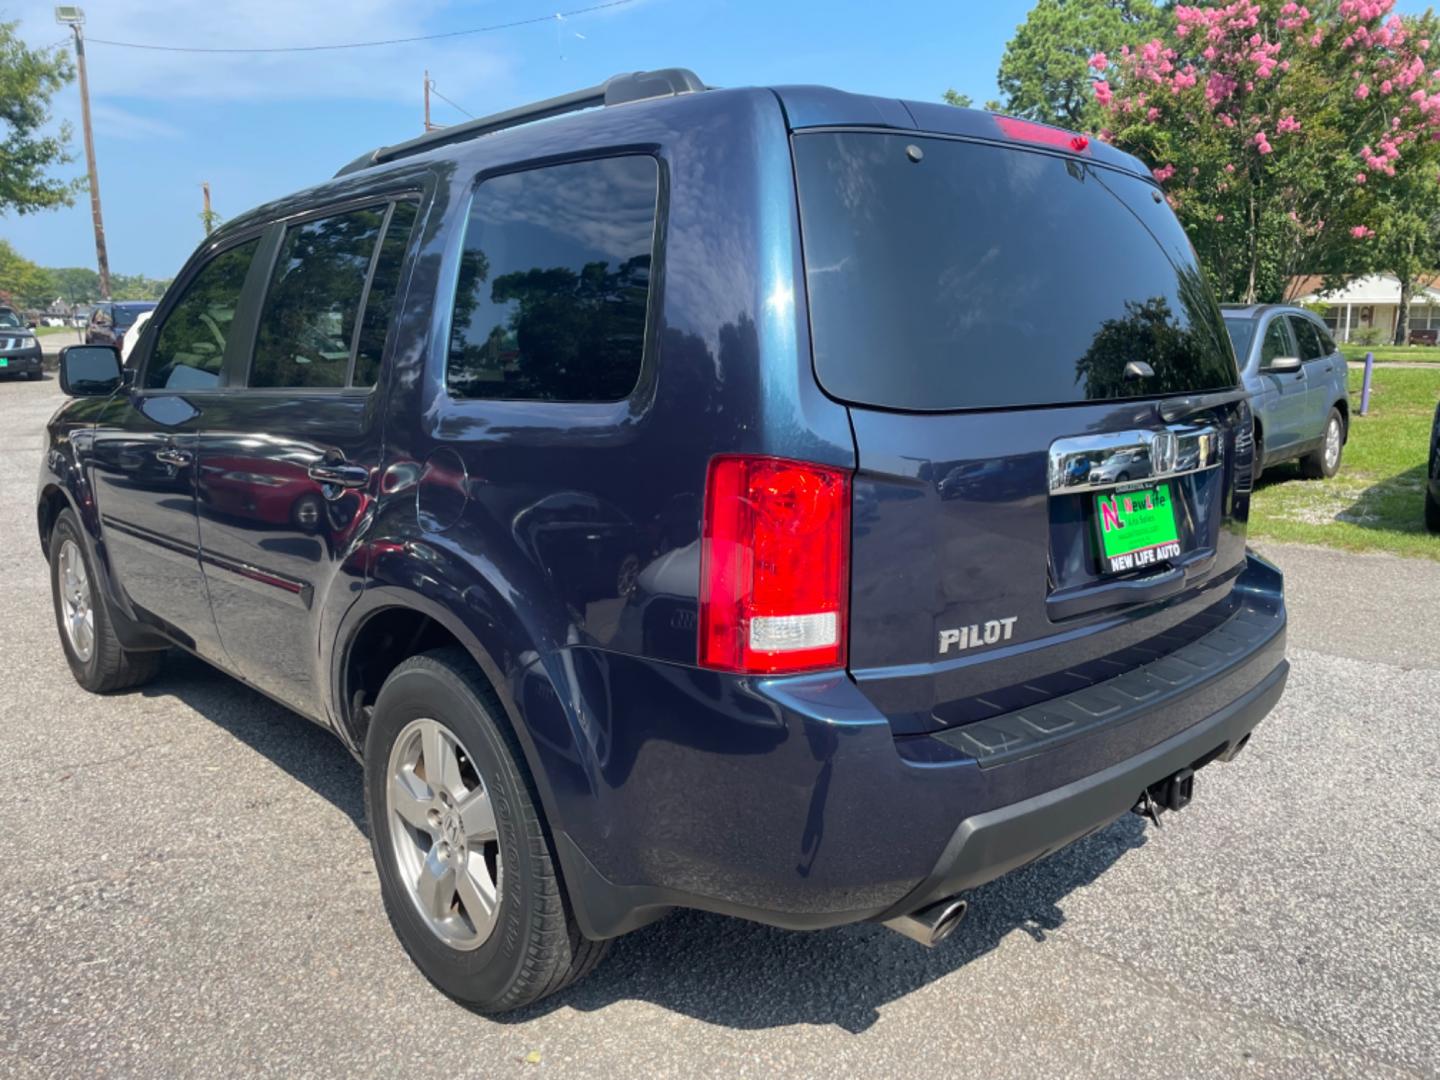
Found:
364,649 -> 608,1012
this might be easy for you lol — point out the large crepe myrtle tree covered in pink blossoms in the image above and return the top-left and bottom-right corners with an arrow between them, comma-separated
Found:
1090,0 -> 1440,302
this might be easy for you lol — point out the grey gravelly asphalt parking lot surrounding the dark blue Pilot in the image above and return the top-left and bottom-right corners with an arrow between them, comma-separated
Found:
0,376 -> 1440,1079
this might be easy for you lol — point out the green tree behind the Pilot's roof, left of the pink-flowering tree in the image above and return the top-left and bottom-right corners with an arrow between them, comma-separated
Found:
999,0 -> 1169,131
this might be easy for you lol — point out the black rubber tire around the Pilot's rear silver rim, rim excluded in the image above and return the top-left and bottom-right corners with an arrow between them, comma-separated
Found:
364,648 -> 609,1012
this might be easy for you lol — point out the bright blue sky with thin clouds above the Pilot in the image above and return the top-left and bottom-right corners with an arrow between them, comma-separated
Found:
0,0 -> 1030,276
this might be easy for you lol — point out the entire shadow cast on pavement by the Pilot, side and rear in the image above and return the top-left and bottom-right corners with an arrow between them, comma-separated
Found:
143,651 -> 1145,1032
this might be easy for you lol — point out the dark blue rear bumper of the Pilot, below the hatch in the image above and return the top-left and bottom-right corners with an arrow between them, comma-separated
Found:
544,556 -> 1289,937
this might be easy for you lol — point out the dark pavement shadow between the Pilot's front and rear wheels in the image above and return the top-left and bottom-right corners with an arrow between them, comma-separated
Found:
141,649 -> 364,832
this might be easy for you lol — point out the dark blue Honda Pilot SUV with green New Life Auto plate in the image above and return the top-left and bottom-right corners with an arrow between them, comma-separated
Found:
39,69 -> 1287,1011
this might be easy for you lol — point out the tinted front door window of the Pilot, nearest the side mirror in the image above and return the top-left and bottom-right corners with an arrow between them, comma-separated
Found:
145,239 -> 259,389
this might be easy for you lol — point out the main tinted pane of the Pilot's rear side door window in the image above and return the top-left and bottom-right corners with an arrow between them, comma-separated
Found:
249,206 -> 384,387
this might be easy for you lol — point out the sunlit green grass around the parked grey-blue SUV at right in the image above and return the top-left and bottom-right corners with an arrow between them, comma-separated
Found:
1250,367 -> 1440,560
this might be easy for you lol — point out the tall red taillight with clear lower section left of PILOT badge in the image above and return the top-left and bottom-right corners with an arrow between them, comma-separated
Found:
700,455 -> 850,674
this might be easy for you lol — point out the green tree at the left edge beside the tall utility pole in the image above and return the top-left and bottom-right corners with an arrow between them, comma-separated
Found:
0,23 -> 81,216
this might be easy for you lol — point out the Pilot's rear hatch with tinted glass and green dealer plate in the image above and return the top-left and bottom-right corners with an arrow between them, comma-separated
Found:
792,114 -> 1250,733
